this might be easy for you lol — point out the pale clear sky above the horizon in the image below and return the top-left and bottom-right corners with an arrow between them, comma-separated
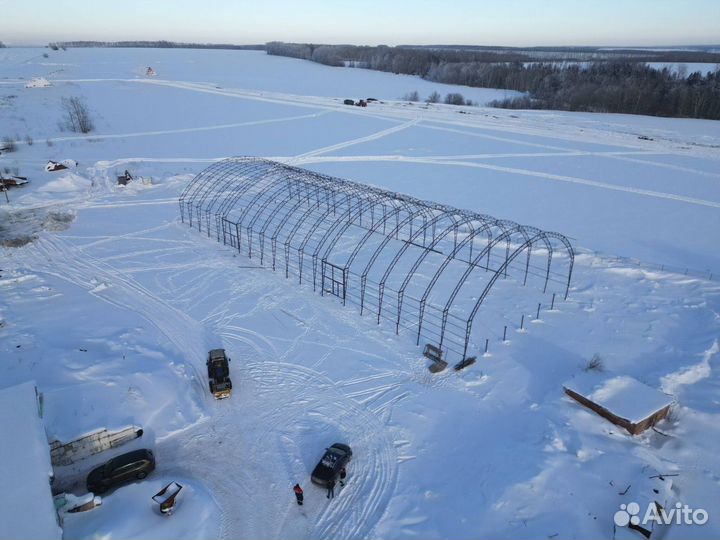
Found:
0,0 -> 720,47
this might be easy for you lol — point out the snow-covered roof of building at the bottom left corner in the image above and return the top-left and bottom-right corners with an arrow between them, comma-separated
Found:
0,381 -> 62,540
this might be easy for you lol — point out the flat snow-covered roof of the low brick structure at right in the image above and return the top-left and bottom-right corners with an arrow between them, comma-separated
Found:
565,374 -> 673,424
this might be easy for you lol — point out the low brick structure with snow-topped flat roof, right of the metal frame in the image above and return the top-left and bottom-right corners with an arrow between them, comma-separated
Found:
563,373 -> 674,435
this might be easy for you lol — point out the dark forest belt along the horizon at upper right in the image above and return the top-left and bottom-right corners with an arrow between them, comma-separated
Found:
266,42 -> 720,120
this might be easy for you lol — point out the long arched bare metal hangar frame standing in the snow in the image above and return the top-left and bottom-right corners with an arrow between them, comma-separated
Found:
179,157 -> 574,358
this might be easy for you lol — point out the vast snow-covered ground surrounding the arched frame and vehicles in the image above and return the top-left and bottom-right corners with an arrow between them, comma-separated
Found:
0,49 -> 720,539
